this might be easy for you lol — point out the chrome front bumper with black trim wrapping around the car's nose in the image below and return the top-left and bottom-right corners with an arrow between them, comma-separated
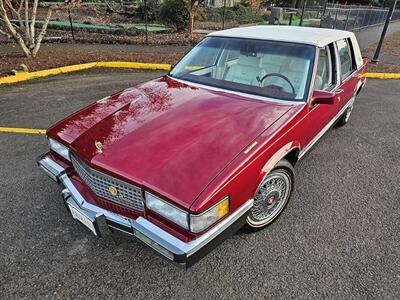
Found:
37,156 -> 253,267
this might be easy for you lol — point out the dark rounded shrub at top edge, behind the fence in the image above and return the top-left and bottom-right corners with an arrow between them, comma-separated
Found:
160,0 -> 189,31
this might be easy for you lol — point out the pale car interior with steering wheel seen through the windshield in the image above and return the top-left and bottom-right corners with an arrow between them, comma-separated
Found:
187,45 -> 310,98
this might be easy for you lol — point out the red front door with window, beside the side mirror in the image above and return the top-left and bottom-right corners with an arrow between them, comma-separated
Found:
306,43 -> 340,147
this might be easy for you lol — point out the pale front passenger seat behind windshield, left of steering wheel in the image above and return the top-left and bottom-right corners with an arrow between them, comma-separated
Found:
224,54 -> 261,86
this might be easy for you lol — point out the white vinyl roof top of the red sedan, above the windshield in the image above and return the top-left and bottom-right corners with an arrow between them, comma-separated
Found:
208,25 -> 355,47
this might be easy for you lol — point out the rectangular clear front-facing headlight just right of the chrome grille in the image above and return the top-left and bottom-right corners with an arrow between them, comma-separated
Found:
145,192 -> 189,229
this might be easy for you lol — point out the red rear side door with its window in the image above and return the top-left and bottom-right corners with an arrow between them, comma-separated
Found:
336,39 -> 359,111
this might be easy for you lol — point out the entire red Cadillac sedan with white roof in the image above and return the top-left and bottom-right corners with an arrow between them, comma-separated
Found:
37,26 -> 367,267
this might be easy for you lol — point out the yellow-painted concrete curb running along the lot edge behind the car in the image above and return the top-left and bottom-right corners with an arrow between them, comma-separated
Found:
0,61 -> 400,85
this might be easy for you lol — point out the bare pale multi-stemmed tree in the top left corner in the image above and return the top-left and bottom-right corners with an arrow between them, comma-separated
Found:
0,0 -> 79,58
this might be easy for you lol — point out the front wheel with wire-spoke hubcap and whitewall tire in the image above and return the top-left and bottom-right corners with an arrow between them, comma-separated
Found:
247,160 -> 294,230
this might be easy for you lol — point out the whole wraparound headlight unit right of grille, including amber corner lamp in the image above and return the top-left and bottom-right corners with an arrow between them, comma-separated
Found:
145,192 -> 229,233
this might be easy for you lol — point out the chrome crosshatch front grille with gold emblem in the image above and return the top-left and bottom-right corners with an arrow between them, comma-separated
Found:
71,154 -> 143,211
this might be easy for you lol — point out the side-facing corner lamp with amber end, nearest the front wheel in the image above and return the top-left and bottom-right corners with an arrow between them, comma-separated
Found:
190,196 -> 229,233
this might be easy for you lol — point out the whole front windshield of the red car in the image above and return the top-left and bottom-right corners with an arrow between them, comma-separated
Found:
169,37 -> 315,101
